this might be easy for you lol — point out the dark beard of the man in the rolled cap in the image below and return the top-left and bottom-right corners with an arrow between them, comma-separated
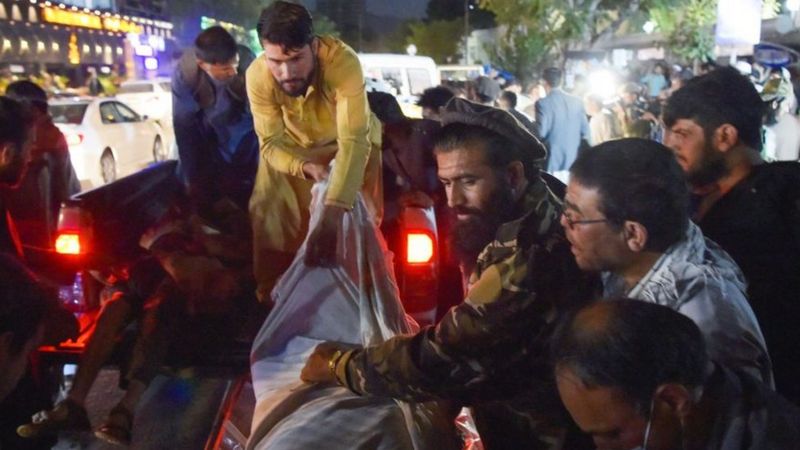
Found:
449,183 -> 514,267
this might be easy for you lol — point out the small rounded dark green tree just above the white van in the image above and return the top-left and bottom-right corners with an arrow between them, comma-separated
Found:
407,19 -> 464,64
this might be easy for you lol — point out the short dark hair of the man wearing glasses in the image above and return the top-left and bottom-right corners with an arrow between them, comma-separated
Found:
570,138 -> 689,252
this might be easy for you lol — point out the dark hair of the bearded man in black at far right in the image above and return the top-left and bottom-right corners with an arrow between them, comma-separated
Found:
663,67 -> 764,150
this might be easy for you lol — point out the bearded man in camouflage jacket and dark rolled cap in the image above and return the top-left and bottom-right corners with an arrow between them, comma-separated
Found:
301,99 -> 596,449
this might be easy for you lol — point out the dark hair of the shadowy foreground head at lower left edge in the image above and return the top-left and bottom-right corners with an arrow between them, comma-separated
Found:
0,254 -> 58,354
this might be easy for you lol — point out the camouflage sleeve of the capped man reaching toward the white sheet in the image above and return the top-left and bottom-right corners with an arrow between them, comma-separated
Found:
337,239 -> 559,401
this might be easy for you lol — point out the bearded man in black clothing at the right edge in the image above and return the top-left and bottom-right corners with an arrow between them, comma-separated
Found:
664,68 -> 800,404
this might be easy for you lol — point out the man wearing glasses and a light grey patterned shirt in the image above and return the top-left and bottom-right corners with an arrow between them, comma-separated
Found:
561,139 -> 773,386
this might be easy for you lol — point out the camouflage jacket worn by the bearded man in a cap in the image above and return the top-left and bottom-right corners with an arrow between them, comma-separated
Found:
336,179 -> 599,448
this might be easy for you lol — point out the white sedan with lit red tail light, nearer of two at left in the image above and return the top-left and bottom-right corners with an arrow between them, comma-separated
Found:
50,98 -> 169,189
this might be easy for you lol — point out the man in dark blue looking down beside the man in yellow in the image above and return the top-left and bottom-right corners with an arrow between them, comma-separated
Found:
172,27 -> 258,213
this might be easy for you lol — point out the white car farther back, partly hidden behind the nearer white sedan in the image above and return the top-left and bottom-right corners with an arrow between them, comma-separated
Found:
116,78 -> 172,123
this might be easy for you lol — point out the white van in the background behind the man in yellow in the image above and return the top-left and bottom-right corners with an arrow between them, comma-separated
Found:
358,53 -> 441,118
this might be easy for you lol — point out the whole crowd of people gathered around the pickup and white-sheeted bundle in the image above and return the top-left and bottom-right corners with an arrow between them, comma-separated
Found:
0,1 -> 800,450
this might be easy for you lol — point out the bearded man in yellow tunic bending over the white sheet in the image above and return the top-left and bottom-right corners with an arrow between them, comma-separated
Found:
247,1 -> 383,301
